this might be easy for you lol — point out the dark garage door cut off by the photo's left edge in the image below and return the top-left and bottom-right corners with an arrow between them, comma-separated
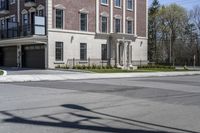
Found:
0,46 -> 17,67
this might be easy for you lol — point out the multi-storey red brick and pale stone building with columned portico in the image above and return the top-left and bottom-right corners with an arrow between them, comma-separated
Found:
0,0 -> 148,68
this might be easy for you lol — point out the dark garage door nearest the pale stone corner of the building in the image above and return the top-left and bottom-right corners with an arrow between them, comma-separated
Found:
22,45 -> 45,69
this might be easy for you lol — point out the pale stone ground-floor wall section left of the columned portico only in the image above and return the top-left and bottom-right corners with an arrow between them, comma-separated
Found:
48,30 -> 107,68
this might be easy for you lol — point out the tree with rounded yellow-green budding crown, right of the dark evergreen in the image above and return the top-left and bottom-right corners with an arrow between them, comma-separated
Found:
159,4 -> 187,63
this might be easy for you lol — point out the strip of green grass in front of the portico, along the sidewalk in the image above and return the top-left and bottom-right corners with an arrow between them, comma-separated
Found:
83,68 -> 187,73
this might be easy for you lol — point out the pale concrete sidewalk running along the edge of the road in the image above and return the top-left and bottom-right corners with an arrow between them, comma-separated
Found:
0,71 -> 200,82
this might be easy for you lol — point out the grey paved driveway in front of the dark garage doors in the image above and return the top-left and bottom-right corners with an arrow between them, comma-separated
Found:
1,68 -> 83,75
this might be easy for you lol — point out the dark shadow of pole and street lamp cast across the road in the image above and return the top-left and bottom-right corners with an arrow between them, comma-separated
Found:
0,104 -> 197,133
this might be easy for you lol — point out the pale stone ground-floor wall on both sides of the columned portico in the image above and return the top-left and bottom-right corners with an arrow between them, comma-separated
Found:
48,29 -> 147,68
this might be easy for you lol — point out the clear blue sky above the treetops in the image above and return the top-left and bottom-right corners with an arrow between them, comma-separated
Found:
149,0 -> 200,10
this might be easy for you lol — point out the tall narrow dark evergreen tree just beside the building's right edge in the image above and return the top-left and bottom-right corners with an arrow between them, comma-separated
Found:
148,0 -> 160,62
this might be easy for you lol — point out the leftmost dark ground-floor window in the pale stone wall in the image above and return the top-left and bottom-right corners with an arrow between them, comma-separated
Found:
55,42 -> 63,61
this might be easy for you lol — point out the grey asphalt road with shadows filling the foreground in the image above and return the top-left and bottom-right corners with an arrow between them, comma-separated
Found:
0,76 -> 200,133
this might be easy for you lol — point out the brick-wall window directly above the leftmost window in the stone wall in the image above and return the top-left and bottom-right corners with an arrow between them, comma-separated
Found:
56,9 -> 63,29
